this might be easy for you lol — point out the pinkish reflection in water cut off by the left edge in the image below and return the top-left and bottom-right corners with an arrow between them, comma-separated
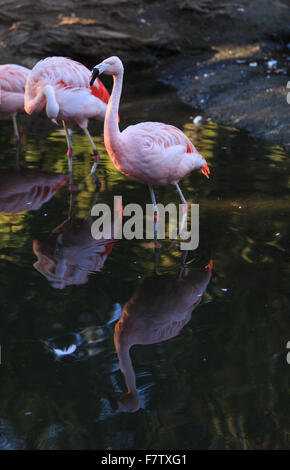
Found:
0,168 -> 68,214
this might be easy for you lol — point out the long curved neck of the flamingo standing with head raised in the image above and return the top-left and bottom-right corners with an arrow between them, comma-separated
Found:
104,70 -> 123,156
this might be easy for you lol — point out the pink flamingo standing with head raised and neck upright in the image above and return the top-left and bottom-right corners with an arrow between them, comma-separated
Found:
90,56 -> 210,241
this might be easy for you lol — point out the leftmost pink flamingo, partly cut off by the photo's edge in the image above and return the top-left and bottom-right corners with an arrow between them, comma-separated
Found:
0,64 -> 30,143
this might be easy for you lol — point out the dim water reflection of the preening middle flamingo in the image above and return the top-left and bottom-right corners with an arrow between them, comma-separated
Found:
33,185 -> 121,289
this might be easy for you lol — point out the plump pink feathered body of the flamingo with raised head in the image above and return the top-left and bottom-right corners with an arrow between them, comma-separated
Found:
112,122 -> 205,185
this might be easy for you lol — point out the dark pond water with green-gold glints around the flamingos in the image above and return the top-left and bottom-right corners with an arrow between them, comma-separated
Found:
0,79 -> 290,449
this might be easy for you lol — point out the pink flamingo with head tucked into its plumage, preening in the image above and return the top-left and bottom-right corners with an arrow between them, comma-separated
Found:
24,57 -> 110,174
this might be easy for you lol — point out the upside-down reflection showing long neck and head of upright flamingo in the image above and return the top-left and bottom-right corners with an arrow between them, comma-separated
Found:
114,255 -> 213,412
